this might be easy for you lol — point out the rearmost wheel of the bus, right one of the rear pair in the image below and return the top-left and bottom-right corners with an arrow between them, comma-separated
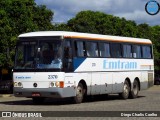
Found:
129,80 -> 139,99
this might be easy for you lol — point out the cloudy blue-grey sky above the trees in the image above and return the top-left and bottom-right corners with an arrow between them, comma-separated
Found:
35,0 -> 160,26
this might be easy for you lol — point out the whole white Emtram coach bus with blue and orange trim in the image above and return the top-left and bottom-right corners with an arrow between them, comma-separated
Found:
13,31 -> 154,103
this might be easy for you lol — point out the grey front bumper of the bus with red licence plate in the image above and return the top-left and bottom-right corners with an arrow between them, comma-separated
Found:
13,87 -> 76,98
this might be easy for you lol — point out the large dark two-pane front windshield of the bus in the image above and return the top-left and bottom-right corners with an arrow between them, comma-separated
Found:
15,40 -> 62,69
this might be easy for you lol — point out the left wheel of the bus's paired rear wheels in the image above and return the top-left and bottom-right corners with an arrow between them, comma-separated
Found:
119,80 -> 130,99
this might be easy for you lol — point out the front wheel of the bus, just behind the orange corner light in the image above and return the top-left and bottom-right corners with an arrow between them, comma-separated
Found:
73,83 -> 85,104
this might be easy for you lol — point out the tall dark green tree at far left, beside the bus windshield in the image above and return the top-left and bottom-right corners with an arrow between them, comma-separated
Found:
0,0 -> 53,67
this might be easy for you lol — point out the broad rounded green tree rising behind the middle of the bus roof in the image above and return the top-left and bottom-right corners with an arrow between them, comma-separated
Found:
67,11 -> 138,37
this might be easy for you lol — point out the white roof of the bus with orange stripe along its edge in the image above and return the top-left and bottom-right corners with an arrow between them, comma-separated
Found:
18,31 -> 152,44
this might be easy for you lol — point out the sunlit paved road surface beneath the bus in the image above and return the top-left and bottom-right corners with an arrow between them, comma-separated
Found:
0,86 -> 160,120
